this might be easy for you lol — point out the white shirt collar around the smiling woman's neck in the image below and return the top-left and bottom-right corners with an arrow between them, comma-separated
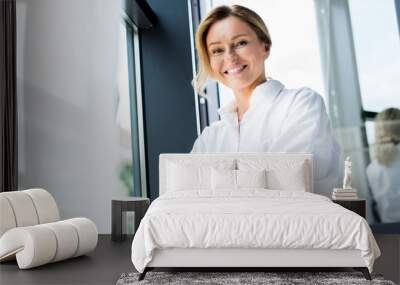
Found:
218,79 -> 284,118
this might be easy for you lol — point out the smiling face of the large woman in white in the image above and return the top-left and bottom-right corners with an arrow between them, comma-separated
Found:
206,16 -> 269,92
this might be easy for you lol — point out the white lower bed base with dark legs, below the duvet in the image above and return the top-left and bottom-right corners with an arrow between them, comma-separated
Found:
139,248 -> 371,280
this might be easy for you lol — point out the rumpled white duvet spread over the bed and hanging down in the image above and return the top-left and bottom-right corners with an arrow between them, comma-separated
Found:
132,189 -> 380,272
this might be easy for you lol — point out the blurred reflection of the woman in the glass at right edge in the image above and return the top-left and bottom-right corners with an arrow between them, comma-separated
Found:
367,108 -> 400,223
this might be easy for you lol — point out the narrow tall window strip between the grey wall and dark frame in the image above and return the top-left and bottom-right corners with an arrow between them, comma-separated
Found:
116,20 -> 146,196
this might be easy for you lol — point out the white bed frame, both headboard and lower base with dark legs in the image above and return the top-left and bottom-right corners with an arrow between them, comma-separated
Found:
139,153 -> 371,280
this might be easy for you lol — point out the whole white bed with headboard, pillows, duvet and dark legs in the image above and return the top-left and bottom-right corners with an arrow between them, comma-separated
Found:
132,153 -> 380,280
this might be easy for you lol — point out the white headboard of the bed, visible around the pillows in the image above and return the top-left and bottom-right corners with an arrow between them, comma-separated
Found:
159,153 -> 314,195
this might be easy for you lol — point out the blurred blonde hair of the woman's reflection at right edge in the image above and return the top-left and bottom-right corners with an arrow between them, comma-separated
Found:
375,108 -> 400,166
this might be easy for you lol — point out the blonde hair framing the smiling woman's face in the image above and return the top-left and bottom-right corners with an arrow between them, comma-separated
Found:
192,5 -> 272,95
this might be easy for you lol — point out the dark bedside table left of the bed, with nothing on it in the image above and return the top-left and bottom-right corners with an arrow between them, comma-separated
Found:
111,197 -> 150,241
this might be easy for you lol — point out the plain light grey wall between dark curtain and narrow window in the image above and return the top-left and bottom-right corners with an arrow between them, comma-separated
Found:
17,0 -> 126,233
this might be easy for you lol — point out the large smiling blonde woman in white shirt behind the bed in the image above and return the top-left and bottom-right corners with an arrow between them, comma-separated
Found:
192,5 -> 339,195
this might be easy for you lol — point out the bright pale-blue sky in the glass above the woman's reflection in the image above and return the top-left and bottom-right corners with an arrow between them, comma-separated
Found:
348,0 -> 400,112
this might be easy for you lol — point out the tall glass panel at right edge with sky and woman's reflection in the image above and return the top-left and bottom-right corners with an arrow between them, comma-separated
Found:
348,0 -> 400,229
